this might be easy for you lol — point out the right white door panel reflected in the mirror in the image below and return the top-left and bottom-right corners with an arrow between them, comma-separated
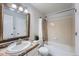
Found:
14,17 -> 27,37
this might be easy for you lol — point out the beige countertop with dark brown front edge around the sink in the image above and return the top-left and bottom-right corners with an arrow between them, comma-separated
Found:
0,42 -> 39,56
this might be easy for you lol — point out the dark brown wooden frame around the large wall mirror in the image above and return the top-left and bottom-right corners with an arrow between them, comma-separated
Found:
0,3 -> 30,43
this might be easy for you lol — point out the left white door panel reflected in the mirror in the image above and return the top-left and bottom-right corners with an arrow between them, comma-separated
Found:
3,14 -> 13,39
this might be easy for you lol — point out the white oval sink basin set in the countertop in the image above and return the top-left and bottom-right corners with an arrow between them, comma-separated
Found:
6,41 -> 31,53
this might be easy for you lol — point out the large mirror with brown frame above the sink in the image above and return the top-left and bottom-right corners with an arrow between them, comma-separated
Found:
2,4 -> 30,41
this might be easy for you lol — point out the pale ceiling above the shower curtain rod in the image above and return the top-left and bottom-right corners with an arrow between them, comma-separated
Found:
31,3 -> 72,15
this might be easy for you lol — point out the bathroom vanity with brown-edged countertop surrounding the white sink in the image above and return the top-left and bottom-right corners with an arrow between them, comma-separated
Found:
0,41 -> 39,56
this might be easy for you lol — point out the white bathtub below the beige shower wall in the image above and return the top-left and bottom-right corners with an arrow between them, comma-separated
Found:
44,42 -> 75,56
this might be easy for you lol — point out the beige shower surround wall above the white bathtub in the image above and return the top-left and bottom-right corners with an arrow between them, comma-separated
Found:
48,16 -> 75,46
